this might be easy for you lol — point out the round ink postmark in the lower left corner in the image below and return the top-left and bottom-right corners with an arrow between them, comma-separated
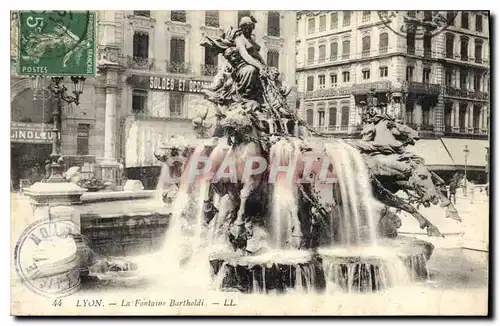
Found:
14,219 -> 80,297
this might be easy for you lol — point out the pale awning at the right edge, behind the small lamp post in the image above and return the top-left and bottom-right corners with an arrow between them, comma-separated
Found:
441,138 -> 490,168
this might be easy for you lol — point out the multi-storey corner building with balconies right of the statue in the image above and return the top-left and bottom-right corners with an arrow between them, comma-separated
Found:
296,11 -> 490,178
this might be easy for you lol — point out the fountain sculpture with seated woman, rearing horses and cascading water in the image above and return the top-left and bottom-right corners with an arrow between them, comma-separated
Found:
151,17 -> 460,292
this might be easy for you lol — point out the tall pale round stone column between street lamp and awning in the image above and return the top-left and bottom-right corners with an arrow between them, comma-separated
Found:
101,68 -> 119,186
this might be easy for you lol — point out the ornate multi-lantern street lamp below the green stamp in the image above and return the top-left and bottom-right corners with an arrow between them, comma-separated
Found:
30,76 -> 85,183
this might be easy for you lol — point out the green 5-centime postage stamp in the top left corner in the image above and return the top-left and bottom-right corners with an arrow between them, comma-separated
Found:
18,11 -> 96,76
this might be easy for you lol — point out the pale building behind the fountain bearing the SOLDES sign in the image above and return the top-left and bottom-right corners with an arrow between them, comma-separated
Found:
12,10 -> 296,188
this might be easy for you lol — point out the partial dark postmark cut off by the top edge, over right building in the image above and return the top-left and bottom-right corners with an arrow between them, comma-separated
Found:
377,10 -> 458,39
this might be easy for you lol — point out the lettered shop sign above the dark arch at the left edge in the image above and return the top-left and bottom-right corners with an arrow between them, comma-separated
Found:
10,122 -> 53,144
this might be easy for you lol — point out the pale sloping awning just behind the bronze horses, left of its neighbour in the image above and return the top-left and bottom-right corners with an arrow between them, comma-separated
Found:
407,139 -> 455,170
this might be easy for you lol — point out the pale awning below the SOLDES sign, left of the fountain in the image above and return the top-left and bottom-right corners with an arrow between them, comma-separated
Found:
125,119 -> 196,168
